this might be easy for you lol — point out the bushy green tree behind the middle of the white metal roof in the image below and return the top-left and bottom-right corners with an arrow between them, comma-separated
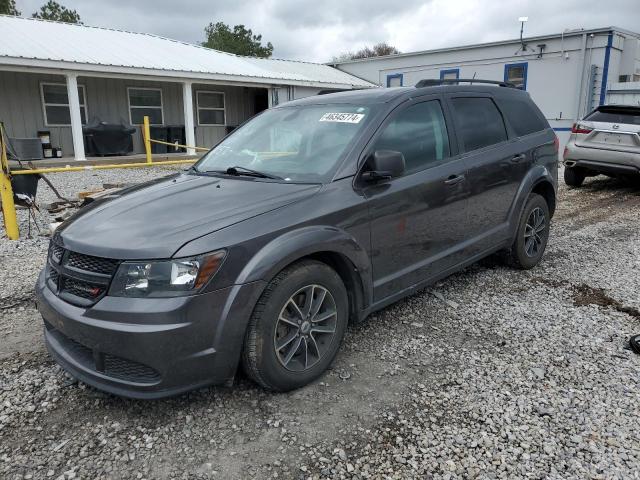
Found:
202,22 -> 273,58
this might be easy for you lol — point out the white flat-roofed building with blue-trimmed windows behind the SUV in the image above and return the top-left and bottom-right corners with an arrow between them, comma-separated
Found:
334,27 -> 640,142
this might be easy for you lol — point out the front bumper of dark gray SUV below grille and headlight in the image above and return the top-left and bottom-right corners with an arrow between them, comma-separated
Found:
36,274 -> 264,399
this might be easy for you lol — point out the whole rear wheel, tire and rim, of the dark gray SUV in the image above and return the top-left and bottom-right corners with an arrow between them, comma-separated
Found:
508,193 -> 551,270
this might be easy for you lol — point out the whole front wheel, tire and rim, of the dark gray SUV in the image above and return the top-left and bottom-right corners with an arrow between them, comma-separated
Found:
242,260 -> 348,392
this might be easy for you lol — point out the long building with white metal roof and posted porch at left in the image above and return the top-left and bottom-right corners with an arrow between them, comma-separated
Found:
0,15 -> 374,160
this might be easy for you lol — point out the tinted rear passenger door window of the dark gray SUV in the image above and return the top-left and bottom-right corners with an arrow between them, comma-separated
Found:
451,97 -> 507,152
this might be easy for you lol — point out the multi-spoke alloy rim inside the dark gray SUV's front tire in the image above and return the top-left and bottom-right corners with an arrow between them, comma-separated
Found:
273,284 -> 338,372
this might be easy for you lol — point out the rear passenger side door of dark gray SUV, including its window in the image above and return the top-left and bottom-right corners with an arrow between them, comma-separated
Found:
448,93 -> 532,256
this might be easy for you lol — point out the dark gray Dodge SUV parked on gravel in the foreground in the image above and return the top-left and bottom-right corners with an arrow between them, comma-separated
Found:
36,80 -> 558,398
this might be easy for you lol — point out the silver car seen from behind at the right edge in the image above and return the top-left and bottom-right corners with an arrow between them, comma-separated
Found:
563,105 -> 640,187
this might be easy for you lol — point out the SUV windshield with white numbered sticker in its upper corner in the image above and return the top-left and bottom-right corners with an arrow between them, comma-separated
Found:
194,104 -> 369,183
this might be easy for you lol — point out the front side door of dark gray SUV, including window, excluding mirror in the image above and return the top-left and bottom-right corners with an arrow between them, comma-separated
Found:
364,97 -> 468,301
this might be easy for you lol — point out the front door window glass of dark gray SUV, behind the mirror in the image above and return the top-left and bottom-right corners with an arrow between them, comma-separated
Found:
374,100 -> 449,173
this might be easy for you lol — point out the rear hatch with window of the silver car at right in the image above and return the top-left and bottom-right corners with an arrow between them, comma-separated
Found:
574,105 -> 640,154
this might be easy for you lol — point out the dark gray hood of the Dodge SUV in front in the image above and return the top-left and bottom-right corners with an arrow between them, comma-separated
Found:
58,174 -> 321,260
